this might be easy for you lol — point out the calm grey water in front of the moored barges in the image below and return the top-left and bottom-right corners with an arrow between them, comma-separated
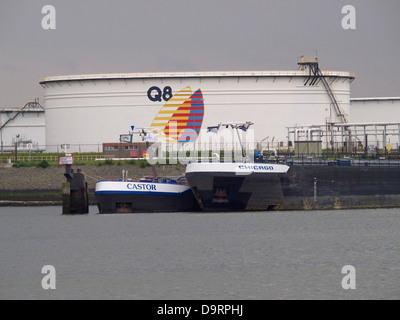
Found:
0,207 -> 400,300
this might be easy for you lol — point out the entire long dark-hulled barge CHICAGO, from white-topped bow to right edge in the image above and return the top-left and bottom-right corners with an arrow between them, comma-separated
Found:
186,162 -> 400,211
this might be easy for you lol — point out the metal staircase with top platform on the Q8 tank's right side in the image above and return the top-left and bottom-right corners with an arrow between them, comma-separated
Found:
297,56 -> 347,123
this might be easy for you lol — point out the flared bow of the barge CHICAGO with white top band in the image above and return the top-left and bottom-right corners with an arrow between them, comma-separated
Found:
185,163 -> 289,211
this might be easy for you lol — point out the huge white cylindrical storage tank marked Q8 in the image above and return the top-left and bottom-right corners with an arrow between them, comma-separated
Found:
39,70 -> 354,152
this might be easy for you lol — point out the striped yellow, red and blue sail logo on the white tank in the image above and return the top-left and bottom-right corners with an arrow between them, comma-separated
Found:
151,86 -> 204,142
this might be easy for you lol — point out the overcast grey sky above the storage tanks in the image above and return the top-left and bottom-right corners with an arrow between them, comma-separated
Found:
0,0 -> 400,108
